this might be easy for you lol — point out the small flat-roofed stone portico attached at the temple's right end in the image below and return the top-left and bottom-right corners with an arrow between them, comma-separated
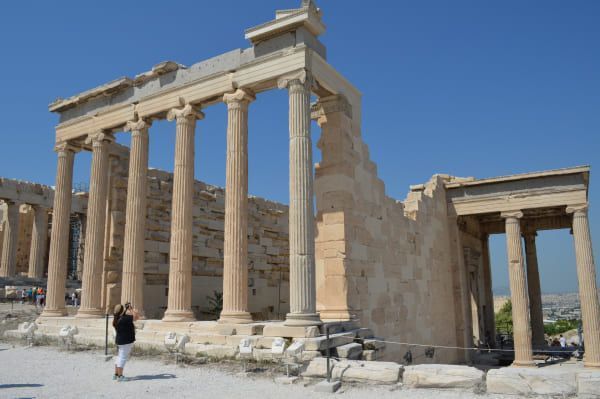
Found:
446,166 -> 600,367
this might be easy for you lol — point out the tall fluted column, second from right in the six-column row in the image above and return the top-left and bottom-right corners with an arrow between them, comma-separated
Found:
219,89 -> 254,323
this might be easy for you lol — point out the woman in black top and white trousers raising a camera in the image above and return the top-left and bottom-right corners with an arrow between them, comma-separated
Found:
113,303 -> 140,381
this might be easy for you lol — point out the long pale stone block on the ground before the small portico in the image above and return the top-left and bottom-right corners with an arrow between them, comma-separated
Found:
486,367 -> 585,396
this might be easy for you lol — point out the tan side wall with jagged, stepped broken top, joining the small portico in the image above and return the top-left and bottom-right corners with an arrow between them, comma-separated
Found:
313,96 -> 462,363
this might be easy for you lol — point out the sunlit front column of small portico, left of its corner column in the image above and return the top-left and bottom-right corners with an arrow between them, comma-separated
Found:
502,211 -> 535,366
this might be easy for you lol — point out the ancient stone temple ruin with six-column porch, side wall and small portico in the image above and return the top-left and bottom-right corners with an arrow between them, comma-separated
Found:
7,1 -> 600,367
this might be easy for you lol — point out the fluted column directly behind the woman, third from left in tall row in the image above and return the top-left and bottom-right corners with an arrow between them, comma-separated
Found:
121,119 -> 150,316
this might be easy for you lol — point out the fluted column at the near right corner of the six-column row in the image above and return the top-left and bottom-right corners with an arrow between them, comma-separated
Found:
278,71 -> 321,326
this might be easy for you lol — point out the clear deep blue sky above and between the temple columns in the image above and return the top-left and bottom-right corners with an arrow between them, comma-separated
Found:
0,0 -> 600,292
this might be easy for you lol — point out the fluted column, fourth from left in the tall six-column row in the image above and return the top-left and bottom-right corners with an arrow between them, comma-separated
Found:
163,104 -> 204,321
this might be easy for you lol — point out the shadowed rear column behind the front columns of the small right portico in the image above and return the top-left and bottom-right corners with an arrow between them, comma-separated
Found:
523,232 -> 547,348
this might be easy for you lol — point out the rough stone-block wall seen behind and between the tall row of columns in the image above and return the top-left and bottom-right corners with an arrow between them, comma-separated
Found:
105,148 -> 289,320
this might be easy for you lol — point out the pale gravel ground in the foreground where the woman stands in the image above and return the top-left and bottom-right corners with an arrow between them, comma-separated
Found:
0,342 -> 528,399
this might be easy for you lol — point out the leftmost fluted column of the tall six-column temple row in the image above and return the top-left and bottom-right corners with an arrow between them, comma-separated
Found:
42,143 -> 77,317
